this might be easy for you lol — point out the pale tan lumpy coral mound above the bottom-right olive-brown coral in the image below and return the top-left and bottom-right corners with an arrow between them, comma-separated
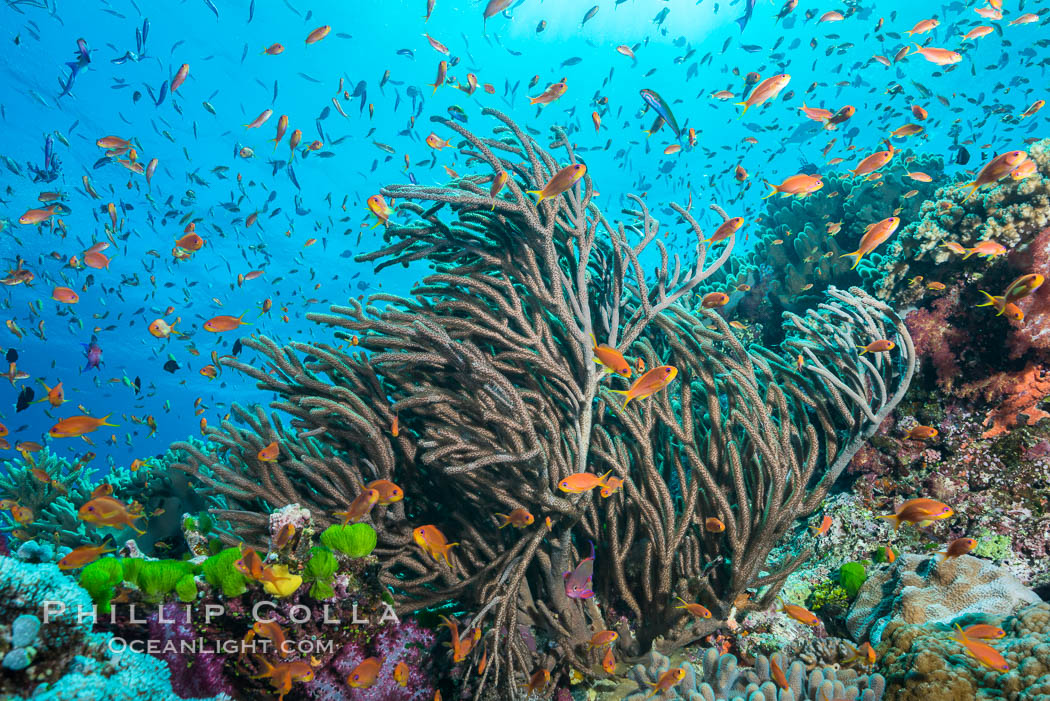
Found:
846,554 -> 1040,644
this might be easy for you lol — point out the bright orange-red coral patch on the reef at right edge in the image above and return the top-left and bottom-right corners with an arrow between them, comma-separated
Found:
959,363 -> 1050,438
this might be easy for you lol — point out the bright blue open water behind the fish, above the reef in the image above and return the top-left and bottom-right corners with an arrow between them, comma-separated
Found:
0,0 -> 1047,482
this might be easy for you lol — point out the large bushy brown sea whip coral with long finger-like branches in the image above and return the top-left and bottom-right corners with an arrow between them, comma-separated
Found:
177,109 -> 915,697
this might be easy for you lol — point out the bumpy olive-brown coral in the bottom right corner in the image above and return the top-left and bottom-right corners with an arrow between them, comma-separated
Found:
878,602 -> 1050,701
